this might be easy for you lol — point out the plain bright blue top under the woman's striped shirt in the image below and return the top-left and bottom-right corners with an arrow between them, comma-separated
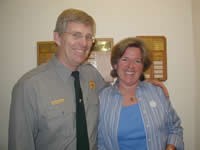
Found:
118,104 -> 147,150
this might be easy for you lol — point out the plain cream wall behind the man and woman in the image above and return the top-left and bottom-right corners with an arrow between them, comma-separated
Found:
0,0 -> 197,150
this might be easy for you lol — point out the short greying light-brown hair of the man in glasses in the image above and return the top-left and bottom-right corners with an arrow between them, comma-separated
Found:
54,8 -> 96,34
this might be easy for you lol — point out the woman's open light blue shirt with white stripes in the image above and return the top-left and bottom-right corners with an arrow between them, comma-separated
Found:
98,82 -> 184,150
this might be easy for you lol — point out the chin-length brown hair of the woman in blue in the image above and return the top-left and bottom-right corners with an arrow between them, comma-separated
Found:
111,37 -> 152,80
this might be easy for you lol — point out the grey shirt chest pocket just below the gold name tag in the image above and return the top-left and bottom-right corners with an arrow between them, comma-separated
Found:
47,103 -> 75,137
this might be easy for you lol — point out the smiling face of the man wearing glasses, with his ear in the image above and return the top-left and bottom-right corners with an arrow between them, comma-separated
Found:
54,22 -> 93,70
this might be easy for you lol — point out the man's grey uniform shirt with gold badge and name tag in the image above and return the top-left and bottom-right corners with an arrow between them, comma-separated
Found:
8,56 -> 105,150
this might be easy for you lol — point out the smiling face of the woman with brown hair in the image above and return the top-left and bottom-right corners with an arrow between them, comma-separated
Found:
114,47 -> 143,86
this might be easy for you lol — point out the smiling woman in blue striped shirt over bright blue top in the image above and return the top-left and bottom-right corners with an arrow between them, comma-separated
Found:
98,38 -> 184,150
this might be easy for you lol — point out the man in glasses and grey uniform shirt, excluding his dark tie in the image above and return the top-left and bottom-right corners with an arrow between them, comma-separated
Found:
8,9 -> 105,150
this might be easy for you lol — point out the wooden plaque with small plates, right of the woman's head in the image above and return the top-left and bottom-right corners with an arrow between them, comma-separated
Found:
137,36 -> 167,81
